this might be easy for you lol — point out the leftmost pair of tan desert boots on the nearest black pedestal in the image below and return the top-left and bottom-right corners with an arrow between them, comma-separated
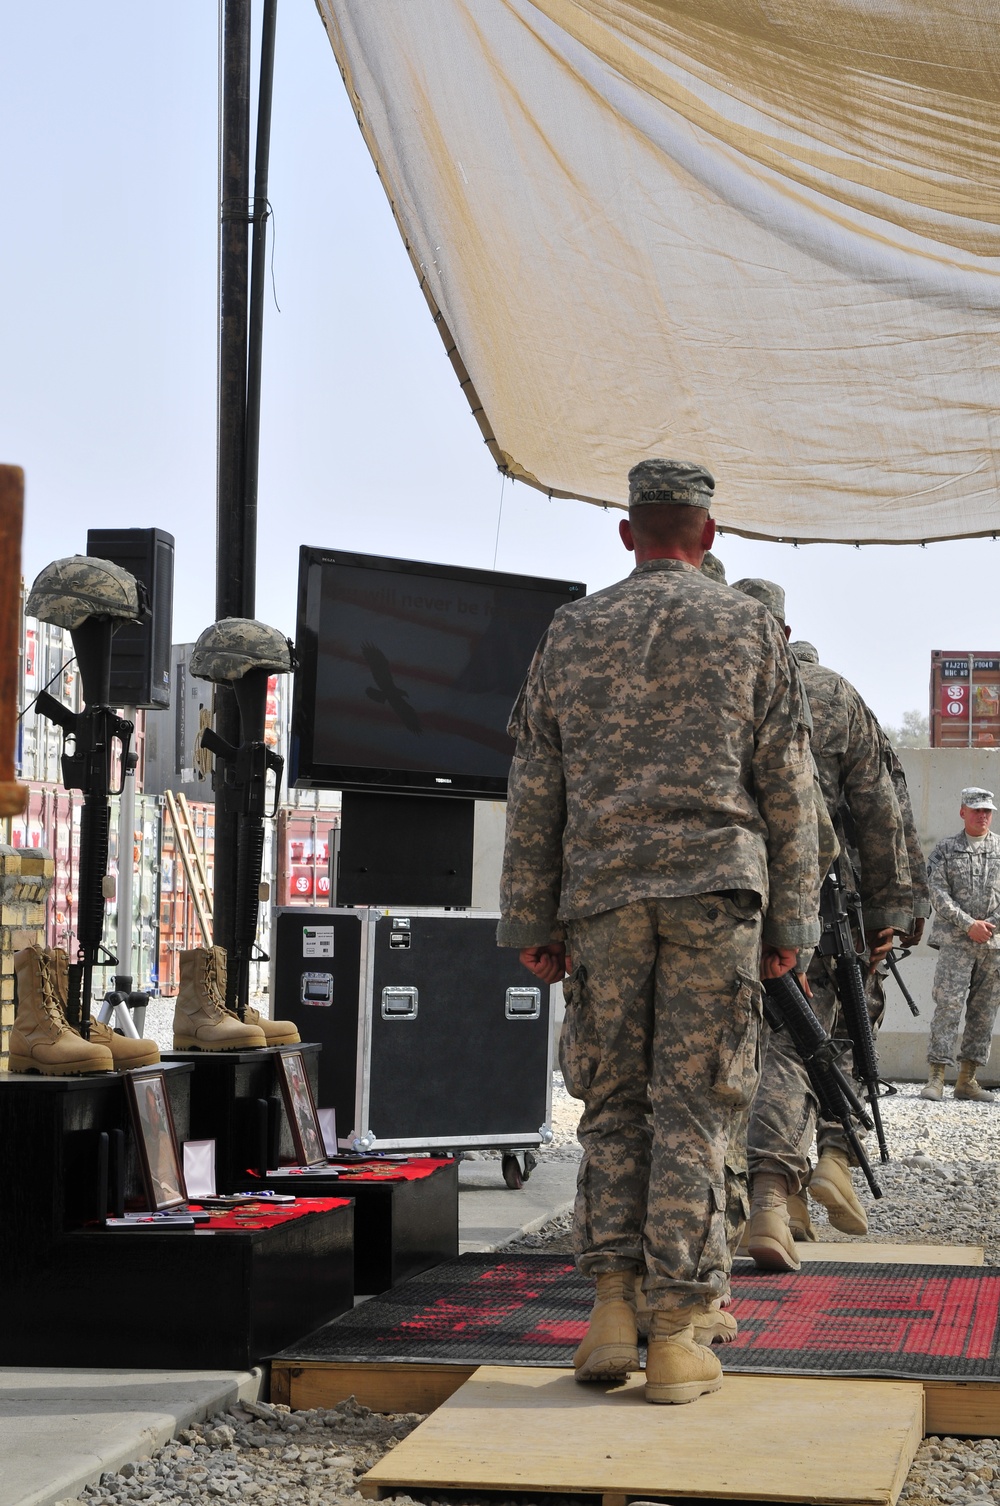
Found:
9,946 -> 160,1077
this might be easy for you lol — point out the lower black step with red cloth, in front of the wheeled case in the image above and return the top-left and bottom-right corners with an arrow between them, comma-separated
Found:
244,1161 -> 458,1295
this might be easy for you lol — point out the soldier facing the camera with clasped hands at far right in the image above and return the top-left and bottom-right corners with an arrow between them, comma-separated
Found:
920,788 -> 1000,1104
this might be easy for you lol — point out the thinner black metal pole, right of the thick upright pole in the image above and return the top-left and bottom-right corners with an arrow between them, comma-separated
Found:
242,0 -> 277,602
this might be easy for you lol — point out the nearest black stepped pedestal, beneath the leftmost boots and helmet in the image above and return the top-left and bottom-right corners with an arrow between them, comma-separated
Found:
0,1063 -> 354,1369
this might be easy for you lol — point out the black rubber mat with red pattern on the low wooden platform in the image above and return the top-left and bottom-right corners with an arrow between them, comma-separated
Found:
277,1254 -> 1000,1381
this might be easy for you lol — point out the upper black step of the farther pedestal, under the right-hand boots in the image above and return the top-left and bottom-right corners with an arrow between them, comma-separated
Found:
163,1042 -> 322,1196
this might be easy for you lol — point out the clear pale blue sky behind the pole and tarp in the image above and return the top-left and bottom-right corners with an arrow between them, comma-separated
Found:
0,0 -> 1000,723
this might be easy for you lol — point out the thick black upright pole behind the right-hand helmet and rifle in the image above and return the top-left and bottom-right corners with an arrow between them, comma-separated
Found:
212,0 -> 255,950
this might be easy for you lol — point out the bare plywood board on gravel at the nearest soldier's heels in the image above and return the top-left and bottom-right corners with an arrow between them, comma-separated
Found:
360,1366 -> 923,1506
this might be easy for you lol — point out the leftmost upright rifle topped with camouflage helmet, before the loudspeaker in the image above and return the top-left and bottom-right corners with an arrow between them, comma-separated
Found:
26,554 -> 148,1041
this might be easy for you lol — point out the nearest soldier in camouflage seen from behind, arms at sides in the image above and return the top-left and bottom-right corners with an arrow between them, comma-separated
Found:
497,459 -> 819,1402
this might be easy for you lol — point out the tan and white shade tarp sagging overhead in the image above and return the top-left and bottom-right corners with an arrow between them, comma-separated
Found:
318,0 -> 1000,544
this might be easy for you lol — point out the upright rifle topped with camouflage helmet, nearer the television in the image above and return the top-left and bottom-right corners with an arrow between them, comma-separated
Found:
191,617 -> 292,1020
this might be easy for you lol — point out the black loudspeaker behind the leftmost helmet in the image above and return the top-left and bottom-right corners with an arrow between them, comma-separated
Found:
87,529 -> 173,711
